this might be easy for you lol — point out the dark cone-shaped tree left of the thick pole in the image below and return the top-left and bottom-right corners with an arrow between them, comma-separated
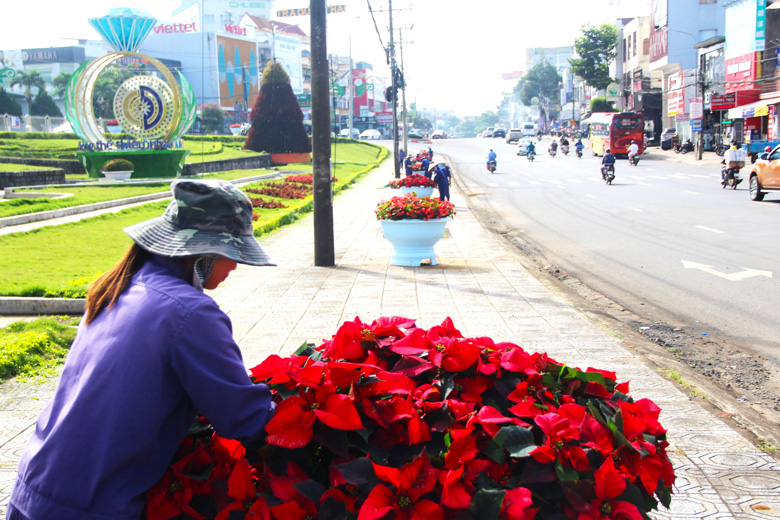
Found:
244,61 -> 311,153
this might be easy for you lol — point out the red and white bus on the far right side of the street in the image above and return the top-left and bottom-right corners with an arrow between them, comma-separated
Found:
587,112 -> 645,155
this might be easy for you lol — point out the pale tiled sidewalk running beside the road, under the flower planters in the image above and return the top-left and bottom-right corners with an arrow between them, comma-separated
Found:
0,164 -> 780,520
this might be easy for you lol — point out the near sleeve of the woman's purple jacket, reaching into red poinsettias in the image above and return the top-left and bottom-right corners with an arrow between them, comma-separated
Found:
169,301 -> 276,445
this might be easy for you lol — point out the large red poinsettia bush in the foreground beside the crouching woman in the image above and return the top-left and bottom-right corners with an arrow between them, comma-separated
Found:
146,317 -> 675,520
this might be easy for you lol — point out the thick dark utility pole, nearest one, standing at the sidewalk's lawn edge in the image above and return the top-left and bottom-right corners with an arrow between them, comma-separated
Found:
310,0 -> 336,267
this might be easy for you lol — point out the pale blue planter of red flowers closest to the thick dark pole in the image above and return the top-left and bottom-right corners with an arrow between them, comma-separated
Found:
375,193 -> 455,267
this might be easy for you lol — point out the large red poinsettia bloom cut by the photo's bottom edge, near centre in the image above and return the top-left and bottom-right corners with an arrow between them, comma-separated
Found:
358,452 -> 444,520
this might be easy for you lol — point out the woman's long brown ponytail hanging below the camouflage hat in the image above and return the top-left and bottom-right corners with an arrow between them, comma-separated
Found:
84,243 -> 152,325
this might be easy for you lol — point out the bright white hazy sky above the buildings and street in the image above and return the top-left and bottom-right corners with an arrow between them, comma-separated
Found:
0,0 -> 649,116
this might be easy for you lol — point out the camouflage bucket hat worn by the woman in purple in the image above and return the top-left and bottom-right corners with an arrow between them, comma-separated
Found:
124,179 -> 276,265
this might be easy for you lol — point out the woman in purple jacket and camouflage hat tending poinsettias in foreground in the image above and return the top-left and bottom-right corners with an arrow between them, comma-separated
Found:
8,180 -> 275,520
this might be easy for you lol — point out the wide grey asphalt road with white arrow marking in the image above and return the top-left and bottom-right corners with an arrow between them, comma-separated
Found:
424,139 -> 780,363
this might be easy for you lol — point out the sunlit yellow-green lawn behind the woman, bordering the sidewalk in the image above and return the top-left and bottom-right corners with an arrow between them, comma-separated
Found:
0,143 -> 389,297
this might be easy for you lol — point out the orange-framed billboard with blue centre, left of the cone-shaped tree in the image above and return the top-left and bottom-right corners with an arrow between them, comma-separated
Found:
216,35 -> 259,110
